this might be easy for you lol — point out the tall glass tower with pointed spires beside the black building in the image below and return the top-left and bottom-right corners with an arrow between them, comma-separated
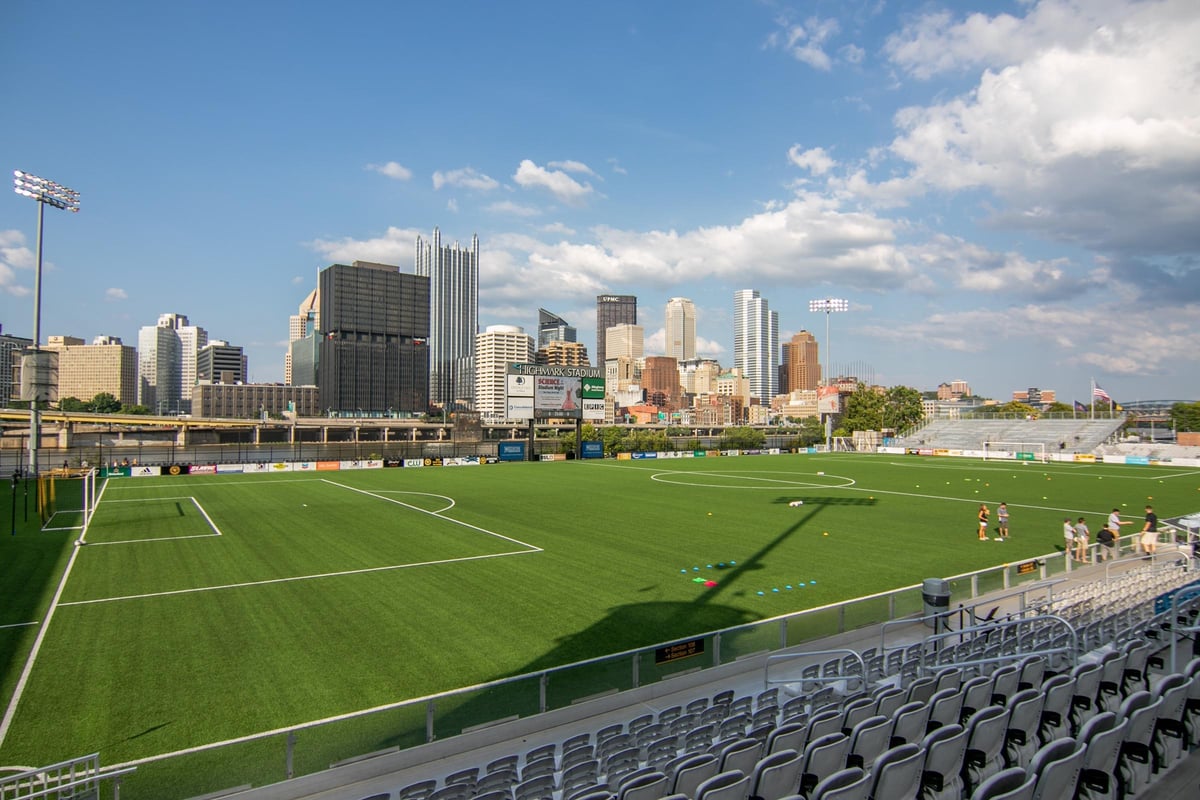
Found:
416,228 -> 479,410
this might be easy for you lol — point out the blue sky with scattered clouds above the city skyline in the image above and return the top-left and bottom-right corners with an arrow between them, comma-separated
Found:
0,0 -> 1200,402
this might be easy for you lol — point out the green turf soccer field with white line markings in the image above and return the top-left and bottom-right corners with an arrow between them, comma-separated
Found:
0,455 -> 1200,798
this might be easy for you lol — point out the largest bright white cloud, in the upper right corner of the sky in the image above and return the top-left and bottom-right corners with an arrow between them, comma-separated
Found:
829,0 -> 1200,272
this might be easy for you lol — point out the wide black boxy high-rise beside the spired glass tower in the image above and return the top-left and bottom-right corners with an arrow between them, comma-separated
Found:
319,261 -> 430,416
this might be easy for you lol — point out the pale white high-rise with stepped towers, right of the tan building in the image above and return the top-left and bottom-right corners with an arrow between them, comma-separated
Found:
138,314 -> 209,414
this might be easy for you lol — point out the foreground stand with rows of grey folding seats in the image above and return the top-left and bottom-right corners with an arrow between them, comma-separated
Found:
213,551 -> 1200,800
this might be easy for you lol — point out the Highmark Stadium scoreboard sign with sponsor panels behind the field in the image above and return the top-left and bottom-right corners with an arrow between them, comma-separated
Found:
505,363 -> 604,421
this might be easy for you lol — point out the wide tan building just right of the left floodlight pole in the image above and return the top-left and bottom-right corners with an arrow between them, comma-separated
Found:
46,336 -> 138,405
